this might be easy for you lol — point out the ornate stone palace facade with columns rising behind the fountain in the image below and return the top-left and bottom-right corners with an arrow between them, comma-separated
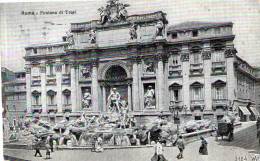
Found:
25,0 -> 256,121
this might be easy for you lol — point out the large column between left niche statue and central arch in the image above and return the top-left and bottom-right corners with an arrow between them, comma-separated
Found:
91,60 -> 99,111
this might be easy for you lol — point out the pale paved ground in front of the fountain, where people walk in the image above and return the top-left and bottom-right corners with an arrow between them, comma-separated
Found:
4,122 -> 260,161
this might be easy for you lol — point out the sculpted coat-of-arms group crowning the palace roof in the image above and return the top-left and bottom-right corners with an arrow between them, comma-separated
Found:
98,0 -> 129,25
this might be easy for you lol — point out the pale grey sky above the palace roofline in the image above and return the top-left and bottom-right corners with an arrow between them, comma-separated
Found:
0,0 -> 260,71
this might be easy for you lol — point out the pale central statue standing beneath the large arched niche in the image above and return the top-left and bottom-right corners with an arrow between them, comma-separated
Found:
108,88 -> 121,112
